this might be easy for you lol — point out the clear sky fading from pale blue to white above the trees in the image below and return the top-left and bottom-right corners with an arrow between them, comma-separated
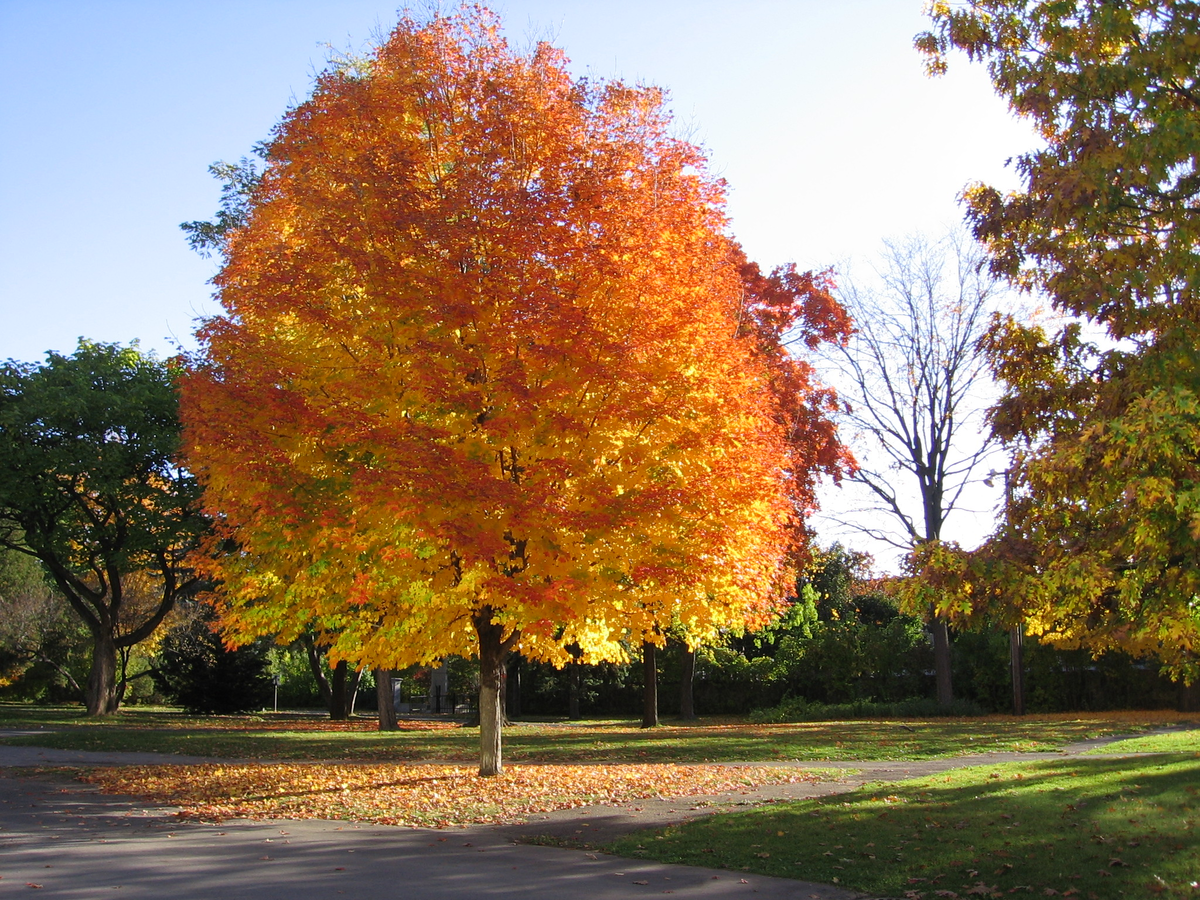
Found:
0,0 -> 1032,360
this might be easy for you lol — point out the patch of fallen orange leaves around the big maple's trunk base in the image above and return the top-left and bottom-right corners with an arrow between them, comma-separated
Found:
83,764 -> 822,827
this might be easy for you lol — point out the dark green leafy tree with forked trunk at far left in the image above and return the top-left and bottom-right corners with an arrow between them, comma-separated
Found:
0,341 -> 206,715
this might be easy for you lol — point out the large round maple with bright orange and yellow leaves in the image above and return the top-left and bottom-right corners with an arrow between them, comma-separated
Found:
184,8 -> 846,774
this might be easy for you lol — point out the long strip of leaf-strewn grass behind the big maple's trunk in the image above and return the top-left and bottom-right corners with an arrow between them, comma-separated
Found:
0,704 -> 1180,762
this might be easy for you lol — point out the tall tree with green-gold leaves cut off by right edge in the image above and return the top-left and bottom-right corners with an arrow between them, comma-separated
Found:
918,0 -> 1200,678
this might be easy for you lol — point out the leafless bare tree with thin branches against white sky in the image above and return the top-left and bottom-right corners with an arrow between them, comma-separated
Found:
834,232 -> 1001,704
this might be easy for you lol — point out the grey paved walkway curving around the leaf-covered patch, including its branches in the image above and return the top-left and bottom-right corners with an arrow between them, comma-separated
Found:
0,738 -> 1180,900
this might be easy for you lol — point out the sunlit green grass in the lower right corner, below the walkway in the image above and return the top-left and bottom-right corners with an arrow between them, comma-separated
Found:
606,754 -> 1200,900
